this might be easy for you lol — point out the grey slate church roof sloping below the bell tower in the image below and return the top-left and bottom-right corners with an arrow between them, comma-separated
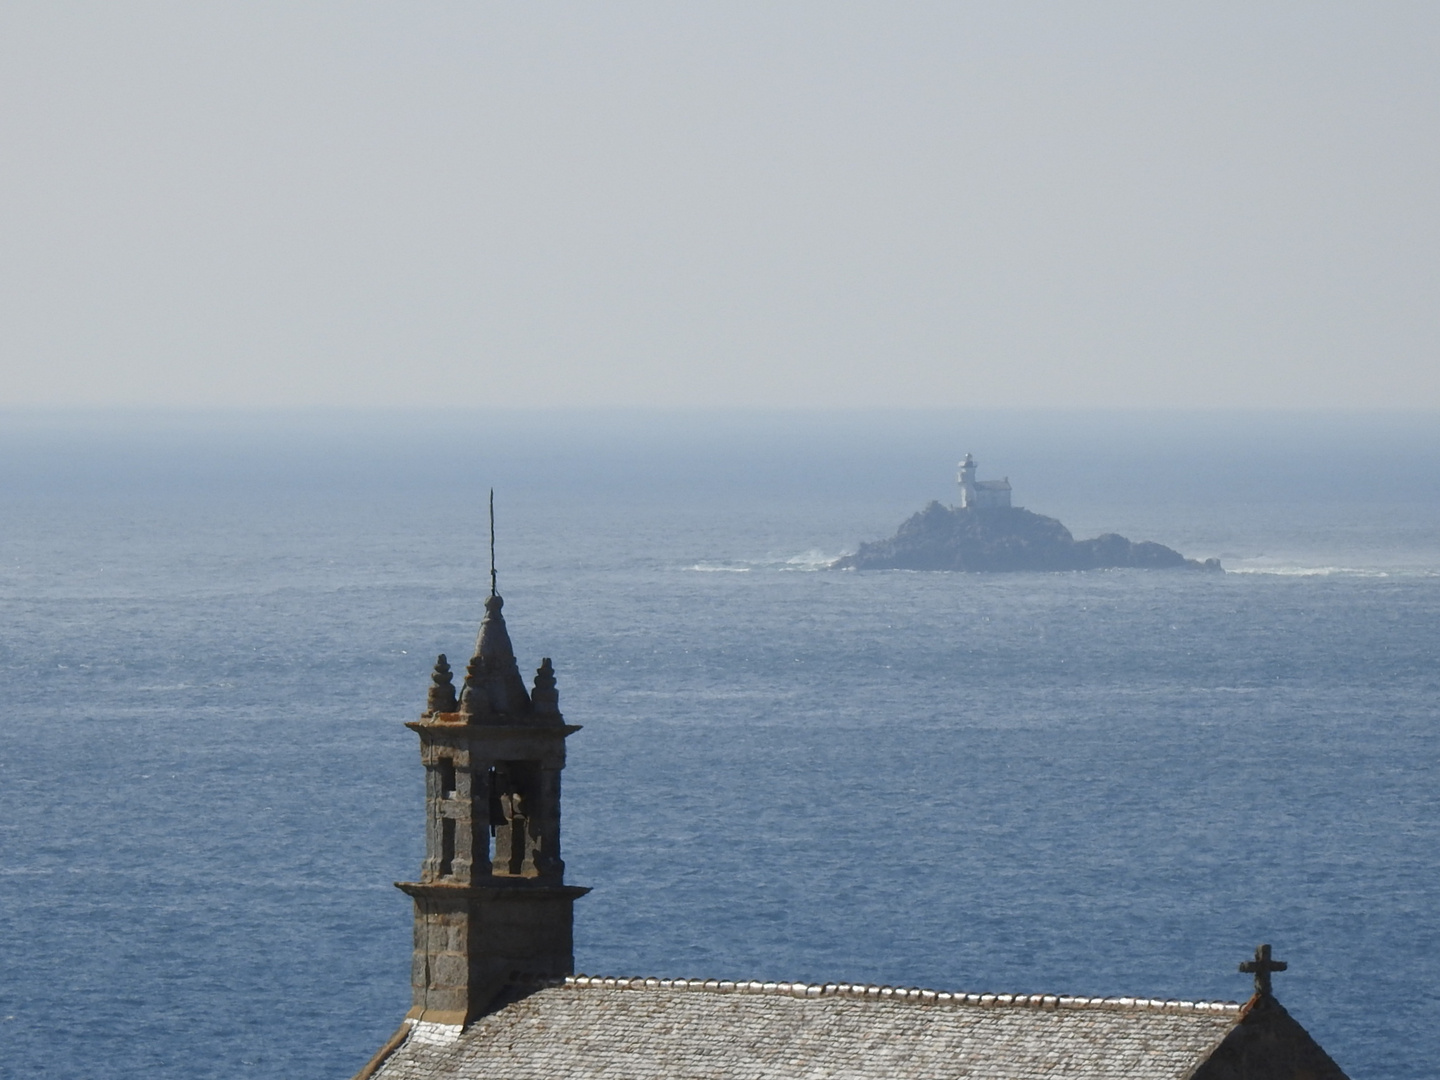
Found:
372,975 -> 1344,1080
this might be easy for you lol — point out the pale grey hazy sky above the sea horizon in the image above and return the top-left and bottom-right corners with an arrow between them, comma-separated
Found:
0,0 -> 1440,409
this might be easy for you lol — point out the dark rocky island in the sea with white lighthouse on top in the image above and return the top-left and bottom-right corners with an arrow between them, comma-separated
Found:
831,454 -> 1221,572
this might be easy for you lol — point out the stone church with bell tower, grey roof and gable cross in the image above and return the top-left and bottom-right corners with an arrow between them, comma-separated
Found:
354,587 -> 1345,1080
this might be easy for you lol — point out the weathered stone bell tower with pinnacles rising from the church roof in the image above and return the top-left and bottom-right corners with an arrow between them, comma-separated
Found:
396,584 -> 590,1024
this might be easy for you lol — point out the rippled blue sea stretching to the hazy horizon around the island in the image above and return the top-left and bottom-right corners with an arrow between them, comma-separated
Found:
0,408 -> 1440,1080
